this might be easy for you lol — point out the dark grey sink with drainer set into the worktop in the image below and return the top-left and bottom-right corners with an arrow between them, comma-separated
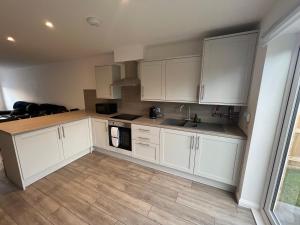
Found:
161,119 -> 224,132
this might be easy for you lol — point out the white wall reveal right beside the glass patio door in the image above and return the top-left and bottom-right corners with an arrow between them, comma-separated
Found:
238,36 -> 297,208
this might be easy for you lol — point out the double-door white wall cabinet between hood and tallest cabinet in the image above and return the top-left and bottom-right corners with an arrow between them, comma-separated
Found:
141,56 -> 201,103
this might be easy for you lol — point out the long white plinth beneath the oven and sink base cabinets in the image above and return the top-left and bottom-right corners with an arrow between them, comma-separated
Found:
93,148 -> 235,192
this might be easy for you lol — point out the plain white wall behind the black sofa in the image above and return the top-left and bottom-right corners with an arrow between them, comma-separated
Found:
0,54 -> 113,109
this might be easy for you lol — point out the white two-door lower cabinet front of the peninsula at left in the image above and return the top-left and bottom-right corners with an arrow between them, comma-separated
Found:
14,119 -> 91,186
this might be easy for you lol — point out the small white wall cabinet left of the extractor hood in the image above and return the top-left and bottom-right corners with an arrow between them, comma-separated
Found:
95,65 -> 121,99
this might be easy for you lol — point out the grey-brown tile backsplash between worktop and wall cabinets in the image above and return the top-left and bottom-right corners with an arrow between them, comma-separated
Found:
84,86 -> 239,124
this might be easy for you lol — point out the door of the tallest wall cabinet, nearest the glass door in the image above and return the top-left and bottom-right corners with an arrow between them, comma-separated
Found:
200,33 -> 257,105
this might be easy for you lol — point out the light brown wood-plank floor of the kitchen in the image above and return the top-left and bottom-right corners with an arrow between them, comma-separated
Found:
0,153 -> 255,225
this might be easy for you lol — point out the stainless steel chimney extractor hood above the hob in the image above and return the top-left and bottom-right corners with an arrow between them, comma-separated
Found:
112,61 -> 141,87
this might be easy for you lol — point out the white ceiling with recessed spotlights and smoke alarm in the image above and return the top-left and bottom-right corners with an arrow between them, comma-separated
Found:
0,0 -> 275,65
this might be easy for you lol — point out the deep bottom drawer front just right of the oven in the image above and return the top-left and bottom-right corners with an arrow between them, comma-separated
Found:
132,140 -> 159,163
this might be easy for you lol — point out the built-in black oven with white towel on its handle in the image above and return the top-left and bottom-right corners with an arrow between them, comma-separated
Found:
108,120 -> 132,154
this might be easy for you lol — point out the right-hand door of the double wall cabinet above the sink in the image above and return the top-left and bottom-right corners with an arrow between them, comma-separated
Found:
166,57 -> 201,103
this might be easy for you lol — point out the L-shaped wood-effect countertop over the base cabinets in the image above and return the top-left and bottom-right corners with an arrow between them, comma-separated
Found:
0,111 -> 247,139
